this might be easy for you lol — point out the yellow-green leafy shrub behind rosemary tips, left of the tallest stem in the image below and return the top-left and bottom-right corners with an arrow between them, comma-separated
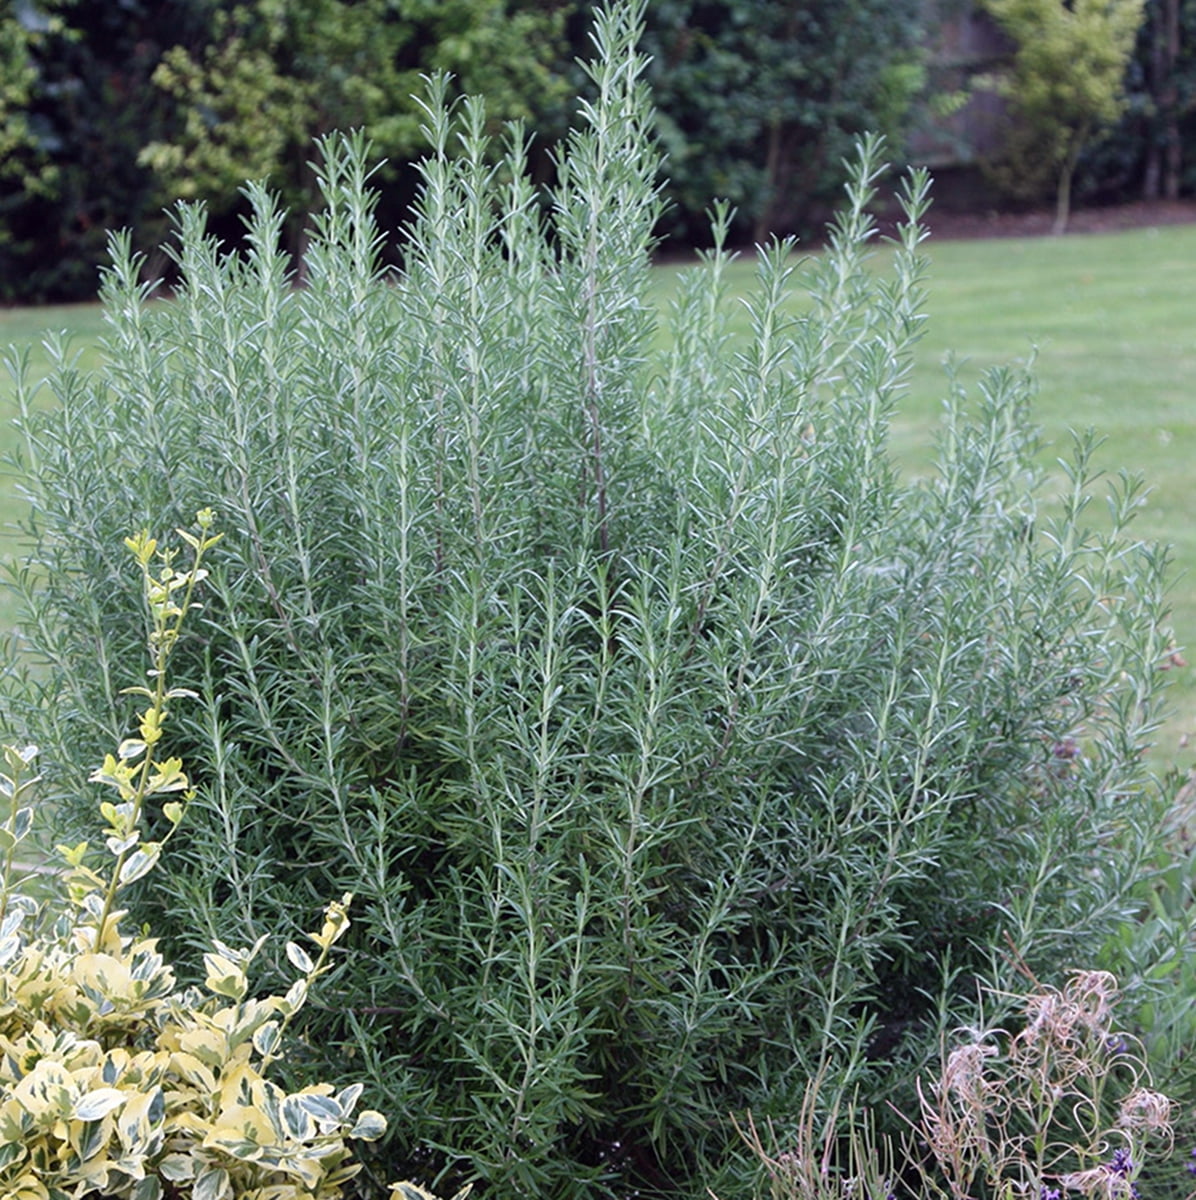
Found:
140,0 -> 571,250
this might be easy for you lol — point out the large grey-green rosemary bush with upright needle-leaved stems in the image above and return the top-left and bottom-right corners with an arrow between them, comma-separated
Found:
0,5 -> 1167,1198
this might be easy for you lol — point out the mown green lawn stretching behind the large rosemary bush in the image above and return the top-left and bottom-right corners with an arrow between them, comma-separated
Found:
7,226 -> 1196,769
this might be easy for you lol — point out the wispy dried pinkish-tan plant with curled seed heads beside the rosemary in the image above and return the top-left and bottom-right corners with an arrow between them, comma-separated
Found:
737,971 -> 1170,1200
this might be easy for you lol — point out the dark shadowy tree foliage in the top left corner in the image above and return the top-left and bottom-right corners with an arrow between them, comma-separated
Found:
0,0 -> 205,301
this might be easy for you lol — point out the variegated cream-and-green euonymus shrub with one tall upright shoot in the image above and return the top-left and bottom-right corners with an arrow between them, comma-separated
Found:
0,511 -> 400,1200
